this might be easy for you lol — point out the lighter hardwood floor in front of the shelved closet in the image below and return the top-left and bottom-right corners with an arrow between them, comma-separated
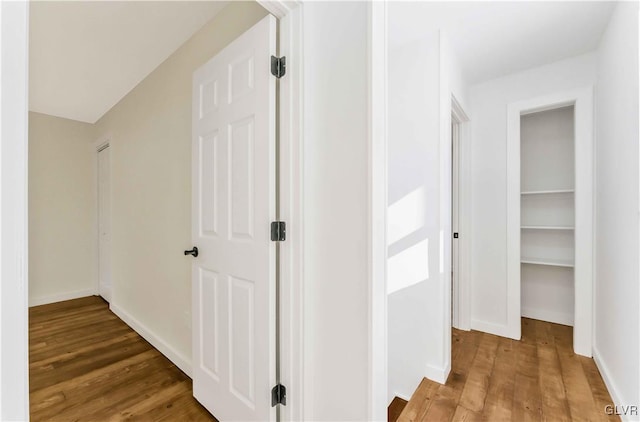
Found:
396,318 -> 619,422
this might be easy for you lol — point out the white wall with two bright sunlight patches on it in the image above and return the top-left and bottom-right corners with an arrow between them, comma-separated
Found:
387,23 -> 466,400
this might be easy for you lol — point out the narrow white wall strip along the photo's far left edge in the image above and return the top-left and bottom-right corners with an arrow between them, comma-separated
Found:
0,2 -> 29,421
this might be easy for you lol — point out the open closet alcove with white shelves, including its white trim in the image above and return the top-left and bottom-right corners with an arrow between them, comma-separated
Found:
506,87 -> 594,356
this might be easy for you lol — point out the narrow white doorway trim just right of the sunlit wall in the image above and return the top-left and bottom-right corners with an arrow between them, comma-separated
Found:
451,95 -> 471,331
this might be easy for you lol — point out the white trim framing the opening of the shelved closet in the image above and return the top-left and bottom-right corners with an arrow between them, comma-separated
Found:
506,86 -> 595,357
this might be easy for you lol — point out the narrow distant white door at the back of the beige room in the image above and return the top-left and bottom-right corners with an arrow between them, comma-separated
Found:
98,146 -> 111,302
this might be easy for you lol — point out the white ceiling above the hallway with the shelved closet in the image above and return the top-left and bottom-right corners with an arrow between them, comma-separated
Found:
388,1 -> 616,84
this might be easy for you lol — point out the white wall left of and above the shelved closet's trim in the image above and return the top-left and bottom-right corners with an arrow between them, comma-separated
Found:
469,53 -> 596,337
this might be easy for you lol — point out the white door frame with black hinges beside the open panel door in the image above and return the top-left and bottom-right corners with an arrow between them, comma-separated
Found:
257,0 -> 305,421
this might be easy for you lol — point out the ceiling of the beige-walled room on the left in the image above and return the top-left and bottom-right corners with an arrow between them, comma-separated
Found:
29,1 -> 228,123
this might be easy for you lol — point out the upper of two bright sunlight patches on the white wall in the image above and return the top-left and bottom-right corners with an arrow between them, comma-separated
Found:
387,187 -> 426,245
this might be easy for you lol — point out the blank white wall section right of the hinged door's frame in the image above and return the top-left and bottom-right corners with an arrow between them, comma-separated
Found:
303,2 -> 370,421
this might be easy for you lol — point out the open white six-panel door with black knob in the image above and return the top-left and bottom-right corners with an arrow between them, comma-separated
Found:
192,16 -> 276,421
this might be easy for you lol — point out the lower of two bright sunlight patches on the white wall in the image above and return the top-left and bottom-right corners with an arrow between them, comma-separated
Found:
387,239 -> 429,294
